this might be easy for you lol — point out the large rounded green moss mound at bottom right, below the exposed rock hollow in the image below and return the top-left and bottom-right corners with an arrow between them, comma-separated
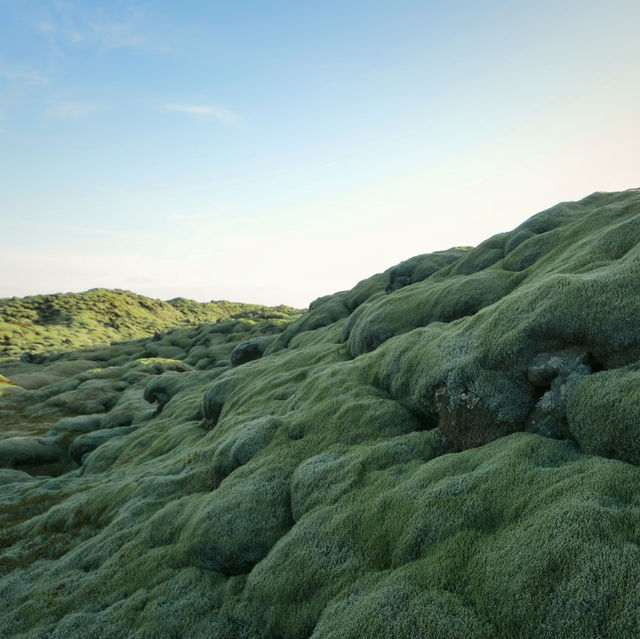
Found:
231,434 -> 638,637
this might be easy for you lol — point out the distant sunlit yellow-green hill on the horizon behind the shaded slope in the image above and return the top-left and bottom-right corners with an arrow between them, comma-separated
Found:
0,288 -> 301,358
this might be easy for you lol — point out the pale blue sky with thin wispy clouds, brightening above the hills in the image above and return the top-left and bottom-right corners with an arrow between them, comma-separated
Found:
0,0 -> 640,307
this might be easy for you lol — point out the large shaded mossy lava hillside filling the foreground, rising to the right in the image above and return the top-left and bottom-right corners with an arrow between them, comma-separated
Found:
0,189 -> 640,639
